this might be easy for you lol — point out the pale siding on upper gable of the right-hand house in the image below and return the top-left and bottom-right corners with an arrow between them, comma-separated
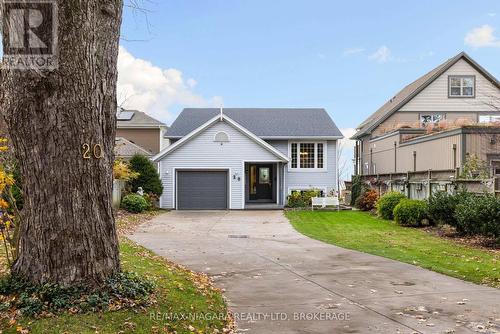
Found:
400,59 -> 500,112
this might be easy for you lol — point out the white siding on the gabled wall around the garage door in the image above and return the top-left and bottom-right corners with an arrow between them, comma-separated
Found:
160,122 -> 279,209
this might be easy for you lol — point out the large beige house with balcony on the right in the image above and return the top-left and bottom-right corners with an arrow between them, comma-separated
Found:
352,52 -> 500,198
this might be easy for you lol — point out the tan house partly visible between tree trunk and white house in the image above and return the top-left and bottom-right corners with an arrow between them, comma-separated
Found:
116,108 -> 169,155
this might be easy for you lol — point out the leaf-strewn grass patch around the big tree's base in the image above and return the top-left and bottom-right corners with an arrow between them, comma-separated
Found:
0,215 -> 231,334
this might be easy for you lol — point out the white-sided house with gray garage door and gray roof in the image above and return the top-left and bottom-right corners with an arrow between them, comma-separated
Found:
153,108 -> 343,209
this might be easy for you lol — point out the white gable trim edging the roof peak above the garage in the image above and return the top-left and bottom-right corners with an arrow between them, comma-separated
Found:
151,114 -> 289,162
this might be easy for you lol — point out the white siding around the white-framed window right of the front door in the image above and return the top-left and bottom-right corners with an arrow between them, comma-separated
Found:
268,140 -> 337,194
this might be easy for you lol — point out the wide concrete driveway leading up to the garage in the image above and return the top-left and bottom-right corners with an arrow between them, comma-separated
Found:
131,211 -> 500,334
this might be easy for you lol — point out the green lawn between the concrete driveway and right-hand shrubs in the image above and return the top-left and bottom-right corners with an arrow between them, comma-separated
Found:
286,211 -> 500,288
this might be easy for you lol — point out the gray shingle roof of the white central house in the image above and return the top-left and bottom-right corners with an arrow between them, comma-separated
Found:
166,108 -> 342,138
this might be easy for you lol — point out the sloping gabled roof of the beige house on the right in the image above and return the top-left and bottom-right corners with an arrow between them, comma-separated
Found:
352,52 -> 500,139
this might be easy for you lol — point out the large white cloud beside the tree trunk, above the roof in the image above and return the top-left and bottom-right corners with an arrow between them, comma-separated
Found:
117,46 -> 222,122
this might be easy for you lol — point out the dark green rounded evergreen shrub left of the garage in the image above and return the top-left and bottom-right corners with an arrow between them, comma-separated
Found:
128,155 -> 163,196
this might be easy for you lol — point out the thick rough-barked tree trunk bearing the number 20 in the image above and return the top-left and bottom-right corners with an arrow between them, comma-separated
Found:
0,0 -> 123,286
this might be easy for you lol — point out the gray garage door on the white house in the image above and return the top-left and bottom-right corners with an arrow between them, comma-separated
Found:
177,171 -> 228,210
